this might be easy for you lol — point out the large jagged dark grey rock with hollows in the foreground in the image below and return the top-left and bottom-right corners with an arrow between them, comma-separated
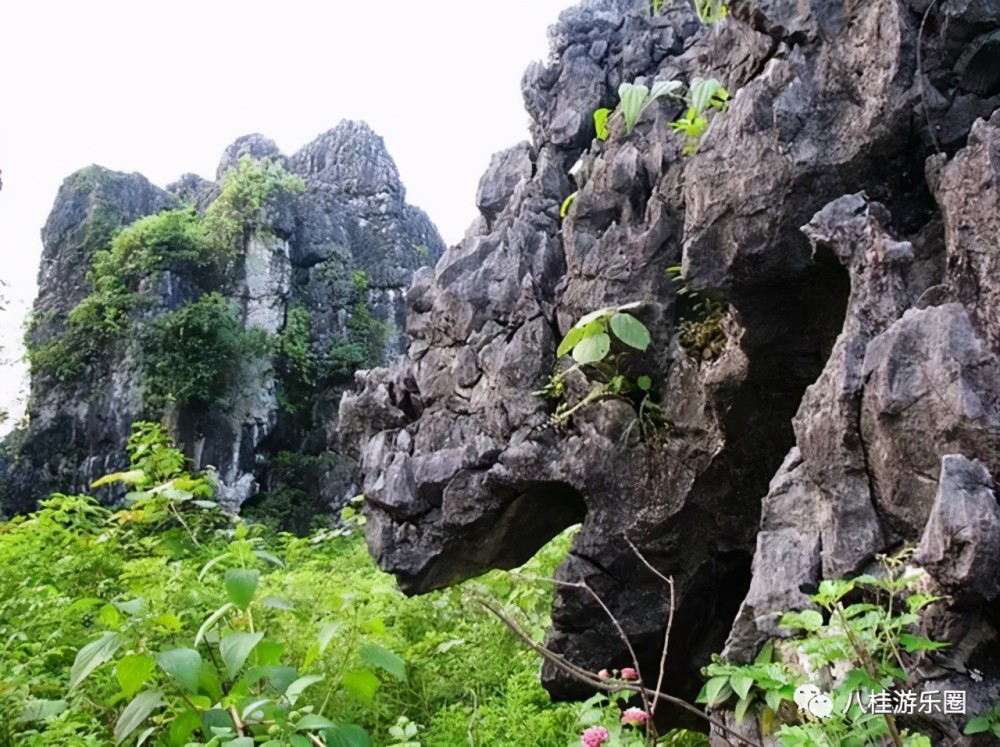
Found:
341,0 -> 1000,730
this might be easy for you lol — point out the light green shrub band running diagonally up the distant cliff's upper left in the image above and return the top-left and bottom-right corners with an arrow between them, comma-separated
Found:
26,157 -> 304,392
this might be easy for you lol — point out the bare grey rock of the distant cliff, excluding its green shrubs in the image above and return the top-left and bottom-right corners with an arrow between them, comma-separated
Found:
0,122 -> 444,514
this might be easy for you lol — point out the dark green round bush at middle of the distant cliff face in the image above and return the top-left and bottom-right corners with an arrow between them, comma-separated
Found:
142,293 -> 268,411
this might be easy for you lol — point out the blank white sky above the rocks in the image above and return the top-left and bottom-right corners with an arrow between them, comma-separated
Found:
0,0 -> 574,428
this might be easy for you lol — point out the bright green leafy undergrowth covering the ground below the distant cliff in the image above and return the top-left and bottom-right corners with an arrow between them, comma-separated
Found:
0,424 -> 577,747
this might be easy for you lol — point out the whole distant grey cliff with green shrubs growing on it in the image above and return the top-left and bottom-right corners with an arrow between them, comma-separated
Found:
0,121 -> 444,529
